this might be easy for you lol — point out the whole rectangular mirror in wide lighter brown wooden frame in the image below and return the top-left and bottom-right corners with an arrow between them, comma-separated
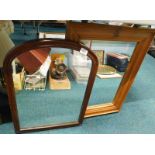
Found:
66,22 -> 155,117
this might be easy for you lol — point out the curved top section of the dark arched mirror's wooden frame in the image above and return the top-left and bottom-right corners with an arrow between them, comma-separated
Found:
3,39 -> 98,72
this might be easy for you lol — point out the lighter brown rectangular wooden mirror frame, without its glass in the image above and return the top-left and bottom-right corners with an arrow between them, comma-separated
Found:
66,22 -> 155,118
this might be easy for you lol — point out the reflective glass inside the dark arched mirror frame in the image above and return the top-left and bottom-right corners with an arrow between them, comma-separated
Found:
12,48 -> 92,128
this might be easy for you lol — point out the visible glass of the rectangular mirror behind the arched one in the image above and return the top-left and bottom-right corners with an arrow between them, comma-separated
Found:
81,40 -> 136,105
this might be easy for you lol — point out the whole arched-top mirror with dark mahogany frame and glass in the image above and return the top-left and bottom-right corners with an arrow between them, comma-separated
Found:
3,39 -> 98,133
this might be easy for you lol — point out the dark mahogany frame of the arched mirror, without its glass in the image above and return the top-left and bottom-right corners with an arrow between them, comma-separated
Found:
3,39 -> 98,133
